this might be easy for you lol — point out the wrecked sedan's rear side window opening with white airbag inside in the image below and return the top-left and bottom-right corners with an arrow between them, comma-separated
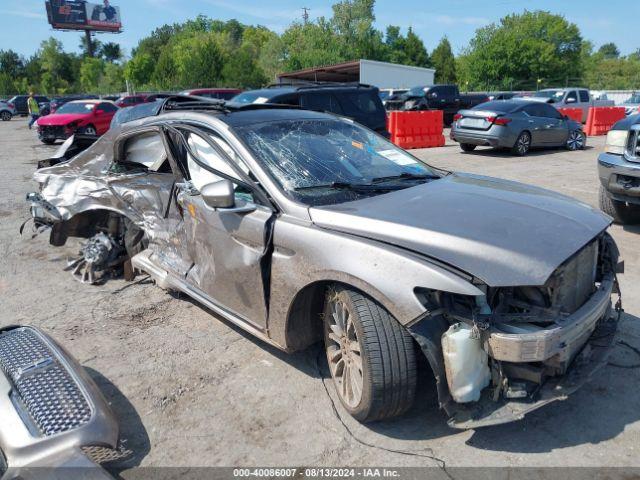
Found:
118,132 -> 171,173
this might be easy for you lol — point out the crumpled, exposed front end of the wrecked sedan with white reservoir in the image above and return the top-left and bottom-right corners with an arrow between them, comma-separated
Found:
410,234 -> 621,428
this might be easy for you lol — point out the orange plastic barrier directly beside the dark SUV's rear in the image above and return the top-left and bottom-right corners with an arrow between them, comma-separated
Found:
387,110 -> 445,149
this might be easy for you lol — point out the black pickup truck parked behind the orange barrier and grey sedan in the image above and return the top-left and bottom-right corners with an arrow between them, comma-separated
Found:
385,85 -> 489,125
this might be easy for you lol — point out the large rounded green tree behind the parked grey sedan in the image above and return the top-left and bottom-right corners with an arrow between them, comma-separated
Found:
459,10 -> 583,89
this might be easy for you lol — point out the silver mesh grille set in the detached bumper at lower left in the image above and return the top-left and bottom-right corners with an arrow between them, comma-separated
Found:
0,328 -> 91,436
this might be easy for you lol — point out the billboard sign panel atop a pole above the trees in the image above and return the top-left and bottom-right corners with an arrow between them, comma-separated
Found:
45,0 -> 122,32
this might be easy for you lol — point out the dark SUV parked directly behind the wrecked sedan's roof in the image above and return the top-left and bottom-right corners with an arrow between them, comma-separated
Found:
231,83 -> 389,138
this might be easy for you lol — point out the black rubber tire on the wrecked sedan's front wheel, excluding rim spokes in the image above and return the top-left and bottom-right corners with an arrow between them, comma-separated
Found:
324,286 -> 416,422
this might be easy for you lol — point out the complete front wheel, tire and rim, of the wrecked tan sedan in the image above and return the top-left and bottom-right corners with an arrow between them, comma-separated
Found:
324,287 -> 416,422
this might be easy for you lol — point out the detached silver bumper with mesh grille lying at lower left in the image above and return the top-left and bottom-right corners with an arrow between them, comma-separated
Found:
0,327 -> 118,479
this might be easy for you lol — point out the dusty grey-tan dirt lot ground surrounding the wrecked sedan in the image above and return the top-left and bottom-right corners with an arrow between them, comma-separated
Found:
0,119 -> 640,477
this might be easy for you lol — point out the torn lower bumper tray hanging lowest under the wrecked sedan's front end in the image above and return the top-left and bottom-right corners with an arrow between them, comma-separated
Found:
448,315 -> 618,429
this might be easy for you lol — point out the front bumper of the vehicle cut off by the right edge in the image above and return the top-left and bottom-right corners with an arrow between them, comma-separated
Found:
598,153 -> 640,205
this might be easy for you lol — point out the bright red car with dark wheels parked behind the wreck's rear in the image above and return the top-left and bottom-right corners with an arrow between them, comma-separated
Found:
37,100 -> 118,145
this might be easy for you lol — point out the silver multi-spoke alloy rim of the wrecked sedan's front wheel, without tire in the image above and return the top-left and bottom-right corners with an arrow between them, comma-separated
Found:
325,300 -> 364,408
